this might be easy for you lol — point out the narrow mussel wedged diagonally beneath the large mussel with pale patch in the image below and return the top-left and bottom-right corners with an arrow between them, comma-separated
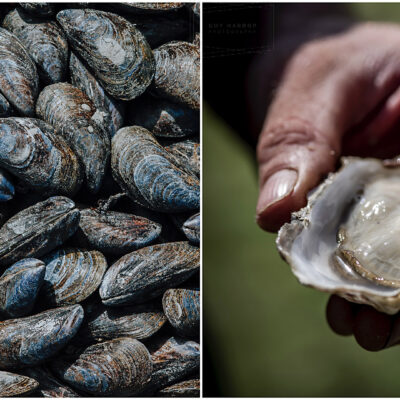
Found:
69,52 -> 125,137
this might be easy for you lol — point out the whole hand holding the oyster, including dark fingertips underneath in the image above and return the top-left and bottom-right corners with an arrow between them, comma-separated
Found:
257,24 -> 400,350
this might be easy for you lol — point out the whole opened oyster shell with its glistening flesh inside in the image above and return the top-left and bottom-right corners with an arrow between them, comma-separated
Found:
276,157 -> 400,314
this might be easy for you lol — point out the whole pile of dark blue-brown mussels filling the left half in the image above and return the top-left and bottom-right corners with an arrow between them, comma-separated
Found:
0,3 -> 200,397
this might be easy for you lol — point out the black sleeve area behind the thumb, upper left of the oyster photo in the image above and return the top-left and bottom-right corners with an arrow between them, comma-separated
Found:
203,3 -> 352,149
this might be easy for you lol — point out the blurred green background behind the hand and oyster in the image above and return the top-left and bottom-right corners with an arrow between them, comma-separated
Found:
203,3 -> 400,397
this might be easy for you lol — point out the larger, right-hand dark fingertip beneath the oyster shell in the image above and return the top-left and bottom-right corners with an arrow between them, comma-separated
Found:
354,305 -> 392,351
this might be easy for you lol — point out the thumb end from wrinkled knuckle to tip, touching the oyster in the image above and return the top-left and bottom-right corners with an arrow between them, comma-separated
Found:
257,119 -> 340,232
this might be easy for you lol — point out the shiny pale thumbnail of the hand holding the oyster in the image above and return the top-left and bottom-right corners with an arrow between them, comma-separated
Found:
257,169 -> 297,214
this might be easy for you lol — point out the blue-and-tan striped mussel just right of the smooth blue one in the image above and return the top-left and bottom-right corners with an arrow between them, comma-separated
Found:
41,249 -> 107,306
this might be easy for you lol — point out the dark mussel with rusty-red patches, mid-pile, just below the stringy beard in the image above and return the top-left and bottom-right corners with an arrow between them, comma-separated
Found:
76,208 -> 161,255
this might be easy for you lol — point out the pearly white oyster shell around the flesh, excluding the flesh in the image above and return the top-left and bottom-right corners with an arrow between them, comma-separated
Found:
277,158 -> 400,313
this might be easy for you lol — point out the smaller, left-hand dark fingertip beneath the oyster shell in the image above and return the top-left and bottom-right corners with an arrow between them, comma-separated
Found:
326,295 -> 356,336
